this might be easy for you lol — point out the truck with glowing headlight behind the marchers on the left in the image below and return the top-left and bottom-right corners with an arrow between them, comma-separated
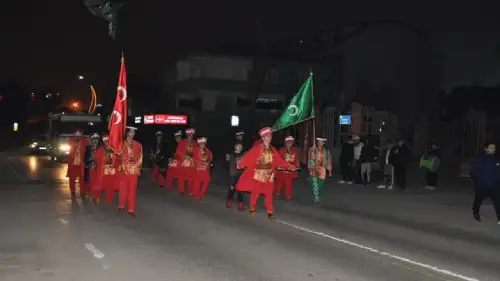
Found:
47,112 -> 105,162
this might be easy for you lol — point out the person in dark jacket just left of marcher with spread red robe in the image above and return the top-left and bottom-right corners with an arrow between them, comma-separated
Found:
226,142 -> 245,212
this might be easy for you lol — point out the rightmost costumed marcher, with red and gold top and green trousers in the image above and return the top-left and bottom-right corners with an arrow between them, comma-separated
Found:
308,138 -> 332,206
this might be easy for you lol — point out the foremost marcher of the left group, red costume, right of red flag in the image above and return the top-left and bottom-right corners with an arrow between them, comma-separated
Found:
118,126 -> 143,217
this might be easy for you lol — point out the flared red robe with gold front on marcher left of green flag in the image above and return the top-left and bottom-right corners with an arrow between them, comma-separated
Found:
236,144 -> 295,194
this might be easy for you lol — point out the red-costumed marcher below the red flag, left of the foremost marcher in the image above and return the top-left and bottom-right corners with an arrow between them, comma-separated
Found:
95,135 -> 120,205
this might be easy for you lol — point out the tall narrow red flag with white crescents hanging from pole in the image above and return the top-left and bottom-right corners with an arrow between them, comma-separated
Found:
108,54 -> 128,152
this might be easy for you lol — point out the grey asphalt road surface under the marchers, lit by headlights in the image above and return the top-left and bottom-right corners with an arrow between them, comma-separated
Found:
0,154 -> 500,281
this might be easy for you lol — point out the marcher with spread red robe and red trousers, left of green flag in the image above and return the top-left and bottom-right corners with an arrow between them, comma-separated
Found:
236,127 -> 295,219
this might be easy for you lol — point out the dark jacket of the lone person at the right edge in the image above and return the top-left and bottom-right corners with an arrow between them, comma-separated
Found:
470,154 -> 500,189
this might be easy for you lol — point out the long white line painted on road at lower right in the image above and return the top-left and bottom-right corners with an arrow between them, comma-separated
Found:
276,220 -> 480,281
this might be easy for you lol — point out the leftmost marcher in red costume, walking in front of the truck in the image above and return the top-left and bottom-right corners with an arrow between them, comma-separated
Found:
66,130 -> 88,195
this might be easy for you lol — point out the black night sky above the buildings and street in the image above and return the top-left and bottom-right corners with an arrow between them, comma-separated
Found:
0,0 -> 500,103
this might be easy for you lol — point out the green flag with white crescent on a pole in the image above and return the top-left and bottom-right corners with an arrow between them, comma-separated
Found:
273,73 -> 315,131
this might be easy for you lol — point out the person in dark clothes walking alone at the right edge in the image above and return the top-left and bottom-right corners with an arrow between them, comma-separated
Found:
470,142 -> 500,224
